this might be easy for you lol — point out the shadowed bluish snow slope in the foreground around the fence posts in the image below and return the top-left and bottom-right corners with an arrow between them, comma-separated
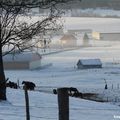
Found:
0,89 -> 120,120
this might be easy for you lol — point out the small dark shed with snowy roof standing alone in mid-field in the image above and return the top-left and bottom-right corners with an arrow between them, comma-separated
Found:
77,59 -> 102,69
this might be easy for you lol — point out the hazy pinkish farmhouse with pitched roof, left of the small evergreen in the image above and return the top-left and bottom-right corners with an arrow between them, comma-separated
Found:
60,34 -> 77,47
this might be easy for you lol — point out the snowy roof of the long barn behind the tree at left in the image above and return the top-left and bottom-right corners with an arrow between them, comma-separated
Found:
3,52 -> 41,62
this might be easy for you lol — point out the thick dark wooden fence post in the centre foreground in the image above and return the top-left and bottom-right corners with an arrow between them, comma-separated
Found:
57,88 -> 69,120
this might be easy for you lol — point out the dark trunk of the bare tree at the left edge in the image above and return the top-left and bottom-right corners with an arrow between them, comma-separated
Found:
0,43 -> 6,100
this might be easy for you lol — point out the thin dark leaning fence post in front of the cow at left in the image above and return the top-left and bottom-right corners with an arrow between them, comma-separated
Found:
24,85 -> 30,120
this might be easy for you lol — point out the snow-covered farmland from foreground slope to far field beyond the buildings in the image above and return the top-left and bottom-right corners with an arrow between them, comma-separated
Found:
0,18 -> 120,120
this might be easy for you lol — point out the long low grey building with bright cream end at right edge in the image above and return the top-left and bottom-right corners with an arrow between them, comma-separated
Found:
92,32 -> 120,41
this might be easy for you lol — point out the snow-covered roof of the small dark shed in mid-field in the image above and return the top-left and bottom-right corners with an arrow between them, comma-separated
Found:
79,59 -> 102,65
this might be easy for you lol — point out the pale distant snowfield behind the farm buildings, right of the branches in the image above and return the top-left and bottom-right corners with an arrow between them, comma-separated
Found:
64,17 -> 120,33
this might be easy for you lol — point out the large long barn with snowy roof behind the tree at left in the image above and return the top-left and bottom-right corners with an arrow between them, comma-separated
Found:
3,52 -> 42,70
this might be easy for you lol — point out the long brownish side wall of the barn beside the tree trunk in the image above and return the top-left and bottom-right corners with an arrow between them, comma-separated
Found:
3,62 -> 29,70
